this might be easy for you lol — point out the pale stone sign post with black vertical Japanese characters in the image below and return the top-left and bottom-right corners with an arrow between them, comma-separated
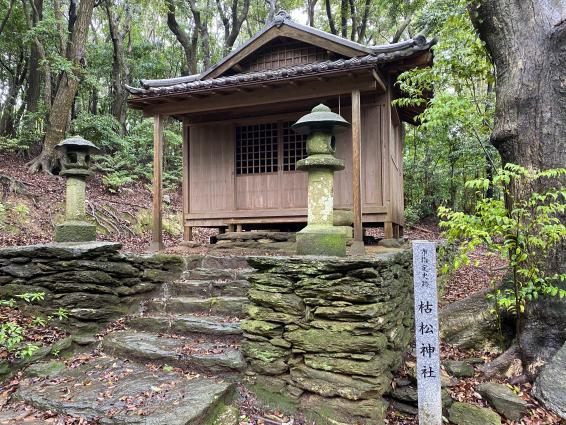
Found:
413,241 -> 442,425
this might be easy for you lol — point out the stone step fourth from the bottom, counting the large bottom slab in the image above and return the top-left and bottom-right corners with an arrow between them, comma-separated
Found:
147,297 -> 249,317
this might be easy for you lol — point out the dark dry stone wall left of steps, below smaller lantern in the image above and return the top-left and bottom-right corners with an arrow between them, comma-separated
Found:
0,242 -> 184,332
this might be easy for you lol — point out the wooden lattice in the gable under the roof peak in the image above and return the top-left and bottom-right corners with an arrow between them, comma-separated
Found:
244,43 -> 328,71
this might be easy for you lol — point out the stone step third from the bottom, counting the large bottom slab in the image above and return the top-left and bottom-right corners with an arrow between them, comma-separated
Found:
126,314 -> 242,337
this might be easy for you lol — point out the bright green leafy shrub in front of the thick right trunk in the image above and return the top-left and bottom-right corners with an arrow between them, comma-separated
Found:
439,164 -> 566,356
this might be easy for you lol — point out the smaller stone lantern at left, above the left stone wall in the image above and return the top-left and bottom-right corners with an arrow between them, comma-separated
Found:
55,136 -> 100,242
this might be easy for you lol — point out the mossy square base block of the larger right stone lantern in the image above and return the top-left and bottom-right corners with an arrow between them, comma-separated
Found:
297,226 -> 346,257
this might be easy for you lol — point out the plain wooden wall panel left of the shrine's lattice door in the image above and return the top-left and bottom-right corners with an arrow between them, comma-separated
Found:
189,124 -> 234,212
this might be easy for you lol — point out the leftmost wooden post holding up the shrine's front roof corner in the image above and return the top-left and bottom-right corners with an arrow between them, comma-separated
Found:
150,114 -> 163,251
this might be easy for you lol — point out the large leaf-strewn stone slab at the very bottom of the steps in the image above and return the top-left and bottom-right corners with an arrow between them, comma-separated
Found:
15,356 -> 234,425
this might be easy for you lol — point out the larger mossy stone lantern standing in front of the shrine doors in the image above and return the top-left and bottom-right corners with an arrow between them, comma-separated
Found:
292,104 -> 350,256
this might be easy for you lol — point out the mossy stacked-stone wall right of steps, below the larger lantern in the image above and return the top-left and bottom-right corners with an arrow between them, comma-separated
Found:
241,251 -> 413,424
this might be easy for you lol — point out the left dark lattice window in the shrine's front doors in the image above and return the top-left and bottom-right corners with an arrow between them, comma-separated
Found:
236,123 -> 278,175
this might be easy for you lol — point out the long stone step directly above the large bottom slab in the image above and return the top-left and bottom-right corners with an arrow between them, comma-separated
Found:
102,330 -> 245,374
